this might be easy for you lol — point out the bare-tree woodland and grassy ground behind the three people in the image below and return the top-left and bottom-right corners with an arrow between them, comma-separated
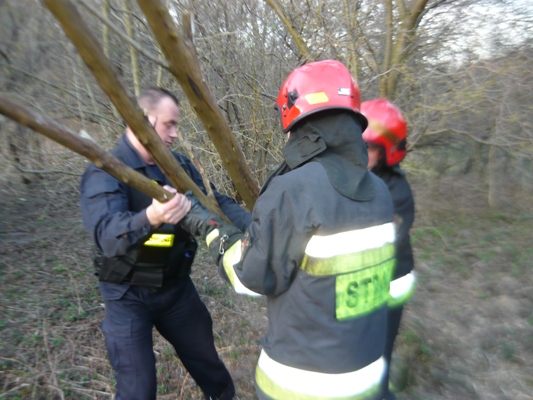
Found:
0,0 -> 533,400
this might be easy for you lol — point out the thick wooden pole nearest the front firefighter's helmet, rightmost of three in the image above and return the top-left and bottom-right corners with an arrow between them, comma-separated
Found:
137,0 -> 259,209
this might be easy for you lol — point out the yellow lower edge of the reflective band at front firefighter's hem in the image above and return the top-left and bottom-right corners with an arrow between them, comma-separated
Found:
255,367 -> 379,400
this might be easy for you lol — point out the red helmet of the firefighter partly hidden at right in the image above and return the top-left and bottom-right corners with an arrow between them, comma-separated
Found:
361,99 -> 407,165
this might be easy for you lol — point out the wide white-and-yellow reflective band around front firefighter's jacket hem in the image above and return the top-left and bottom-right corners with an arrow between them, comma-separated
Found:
255,350 -> 386,400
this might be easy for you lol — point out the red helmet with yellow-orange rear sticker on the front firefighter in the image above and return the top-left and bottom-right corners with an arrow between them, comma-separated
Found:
276,60 -> 367,133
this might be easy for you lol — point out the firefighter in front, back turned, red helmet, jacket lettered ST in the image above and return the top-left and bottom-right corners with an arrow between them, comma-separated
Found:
181,60 -> 394,399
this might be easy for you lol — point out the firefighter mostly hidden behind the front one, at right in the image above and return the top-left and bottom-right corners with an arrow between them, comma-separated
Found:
361,99 -> 415,400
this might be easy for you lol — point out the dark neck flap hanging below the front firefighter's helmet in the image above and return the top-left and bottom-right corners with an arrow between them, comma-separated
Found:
282,110 -> 374,201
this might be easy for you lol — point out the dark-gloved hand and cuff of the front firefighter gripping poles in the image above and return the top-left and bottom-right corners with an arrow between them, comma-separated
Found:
180,190 -> 243,264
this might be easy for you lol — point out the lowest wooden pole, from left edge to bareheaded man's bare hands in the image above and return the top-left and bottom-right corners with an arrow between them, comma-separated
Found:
0,95 -> 173,202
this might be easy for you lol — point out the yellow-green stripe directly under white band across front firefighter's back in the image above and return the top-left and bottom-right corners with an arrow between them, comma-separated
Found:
300,244 -> 394,276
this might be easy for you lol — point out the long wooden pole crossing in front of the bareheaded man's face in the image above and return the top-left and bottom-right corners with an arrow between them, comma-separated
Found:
43,0 -> 229,222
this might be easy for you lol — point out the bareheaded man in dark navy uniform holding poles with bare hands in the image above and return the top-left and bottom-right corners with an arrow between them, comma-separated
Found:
80,88 -> 251,400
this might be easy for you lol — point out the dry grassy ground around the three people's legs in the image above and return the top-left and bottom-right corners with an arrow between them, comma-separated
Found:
0,176 -> 533,400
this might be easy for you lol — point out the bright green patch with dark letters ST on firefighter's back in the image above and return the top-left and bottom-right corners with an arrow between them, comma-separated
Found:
335,259 -> 395,321
